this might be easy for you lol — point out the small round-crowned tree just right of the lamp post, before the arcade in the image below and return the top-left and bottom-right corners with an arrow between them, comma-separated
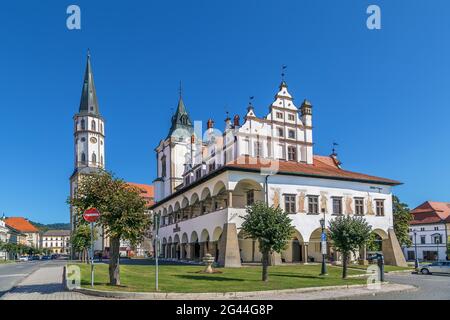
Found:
329,216 -> 372,279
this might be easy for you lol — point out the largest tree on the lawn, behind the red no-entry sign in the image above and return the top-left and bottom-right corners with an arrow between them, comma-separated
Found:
68,171 -> 151,285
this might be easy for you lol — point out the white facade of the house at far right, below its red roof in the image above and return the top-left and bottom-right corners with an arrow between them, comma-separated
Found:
403,223 -> 447,261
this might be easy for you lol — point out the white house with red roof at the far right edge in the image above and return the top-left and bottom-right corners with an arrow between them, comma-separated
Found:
403,201 -> 450,261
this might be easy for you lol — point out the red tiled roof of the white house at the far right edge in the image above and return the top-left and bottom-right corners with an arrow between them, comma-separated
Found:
411,201 -> 450,225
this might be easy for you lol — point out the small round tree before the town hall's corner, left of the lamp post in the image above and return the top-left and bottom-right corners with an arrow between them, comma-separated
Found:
241,202 -> 294,281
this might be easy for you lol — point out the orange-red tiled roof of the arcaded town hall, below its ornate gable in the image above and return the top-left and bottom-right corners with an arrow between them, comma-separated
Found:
226,156 -> 401,186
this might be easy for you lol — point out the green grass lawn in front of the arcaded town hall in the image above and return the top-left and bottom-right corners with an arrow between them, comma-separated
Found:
69,264 -> 366,292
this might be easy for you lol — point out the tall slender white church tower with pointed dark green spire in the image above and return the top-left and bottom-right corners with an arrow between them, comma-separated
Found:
70,52 -> 105,258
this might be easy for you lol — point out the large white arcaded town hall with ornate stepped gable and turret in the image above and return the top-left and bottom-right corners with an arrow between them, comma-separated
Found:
152,80 -> 406,267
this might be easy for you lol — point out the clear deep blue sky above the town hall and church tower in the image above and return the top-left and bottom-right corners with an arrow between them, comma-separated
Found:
0,0 -> 450,223
